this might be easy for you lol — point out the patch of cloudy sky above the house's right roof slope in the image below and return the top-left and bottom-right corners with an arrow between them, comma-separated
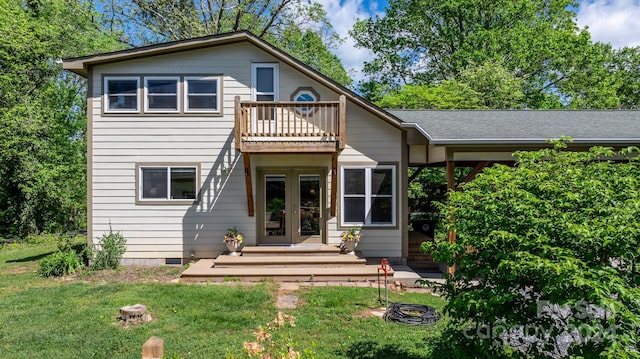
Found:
316,0 -> 386,82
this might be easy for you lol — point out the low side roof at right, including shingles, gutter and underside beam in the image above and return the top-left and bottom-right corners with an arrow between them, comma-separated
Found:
388,110 -> 640,166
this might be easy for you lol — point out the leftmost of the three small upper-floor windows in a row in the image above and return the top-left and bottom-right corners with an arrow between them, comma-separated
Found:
104,77 -> 140,113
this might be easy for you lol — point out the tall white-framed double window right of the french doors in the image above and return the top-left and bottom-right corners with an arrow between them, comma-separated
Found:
341,166 -> 396,226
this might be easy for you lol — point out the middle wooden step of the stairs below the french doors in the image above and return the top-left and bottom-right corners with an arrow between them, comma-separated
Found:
213,254 -> 367,268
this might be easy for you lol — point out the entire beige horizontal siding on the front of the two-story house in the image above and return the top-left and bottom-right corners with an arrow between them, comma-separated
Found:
89,44 -> 405,263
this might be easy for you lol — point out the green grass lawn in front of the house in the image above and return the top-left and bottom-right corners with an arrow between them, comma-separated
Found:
0,240 -> 446,359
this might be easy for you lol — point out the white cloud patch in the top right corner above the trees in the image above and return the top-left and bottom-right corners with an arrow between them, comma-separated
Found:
577,0 -> 640,48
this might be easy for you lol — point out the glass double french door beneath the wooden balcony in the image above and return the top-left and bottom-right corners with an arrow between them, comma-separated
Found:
258,169 -> 326,244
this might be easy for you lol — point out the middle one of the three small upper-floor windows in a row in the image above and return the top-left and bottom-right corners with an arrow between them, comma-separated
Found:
144,77 -> 180,112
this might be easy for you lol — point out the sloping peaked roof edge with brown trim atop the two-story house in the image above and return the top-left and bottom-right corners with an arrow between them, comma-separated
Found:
63,31 -> 401,128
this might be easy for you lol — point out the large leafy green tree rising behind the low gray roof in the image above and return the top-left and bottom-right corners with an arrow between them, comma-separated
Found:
352,0 -> 629,108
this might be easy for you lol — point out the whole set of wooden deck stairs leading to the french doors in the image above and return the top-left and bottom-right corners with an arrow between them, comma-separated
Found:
182,246 -> 390,282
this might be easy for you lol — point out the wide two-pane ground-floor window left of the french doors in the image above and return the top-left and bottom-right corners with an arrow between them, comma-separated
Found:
139,166 -> 198,201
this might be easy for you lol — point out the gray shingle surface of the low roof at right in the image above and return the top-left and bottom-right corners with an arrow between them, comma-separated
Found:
387,110 -> 640,144
